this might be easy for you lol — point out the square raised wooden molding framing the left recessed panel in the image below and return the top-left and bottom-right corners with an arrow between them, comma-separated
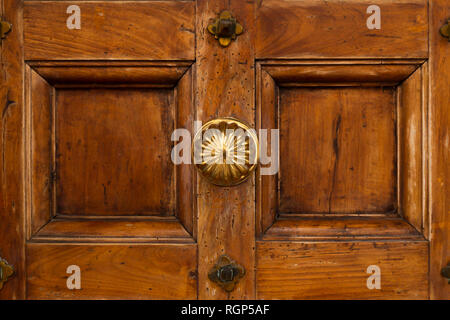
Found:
25,61 -> 195,243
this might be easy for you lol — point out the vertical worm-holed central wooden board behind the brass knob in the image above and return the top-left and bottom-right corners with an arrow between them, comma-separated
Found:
196,0 -> 255,299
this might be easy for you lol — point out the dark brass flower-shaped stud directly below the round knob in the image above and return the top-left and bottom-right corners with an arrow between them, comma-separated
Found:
208,255 -> 245,292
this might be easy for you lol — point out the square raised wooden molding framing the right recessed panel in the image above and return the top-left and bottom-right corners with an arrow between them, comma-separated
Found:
256,59 -> 428,240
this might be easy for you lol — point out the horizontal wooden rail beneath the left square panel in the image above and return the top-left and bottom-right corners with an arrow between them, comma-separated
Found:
27,244 -> 197,299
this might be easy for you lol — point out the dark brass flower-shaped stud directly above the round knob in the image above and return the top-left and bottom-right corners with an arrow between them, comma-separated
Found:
208,11 -> 244,47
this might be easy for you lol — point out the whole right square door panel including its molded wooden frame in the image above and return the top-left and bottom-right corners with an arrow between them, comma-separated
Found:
258,61 -> 428,237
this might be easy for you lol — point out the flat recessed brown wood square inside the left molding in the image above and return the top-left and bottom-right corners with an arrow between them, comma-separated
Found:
56,88 -> 175,215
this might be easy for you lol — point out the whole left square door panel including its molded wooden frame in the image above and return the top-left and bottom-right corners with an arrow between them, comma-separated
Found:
27,63 -> 193,237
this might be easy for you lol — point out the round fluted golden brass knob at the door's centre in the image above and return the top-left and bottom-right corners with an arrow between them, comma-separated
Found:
192,118 -> 258,186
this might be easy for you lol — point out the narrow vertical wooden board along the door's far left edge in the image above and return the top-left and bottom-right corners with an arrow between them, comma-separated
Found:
0,0 -> 25,299
